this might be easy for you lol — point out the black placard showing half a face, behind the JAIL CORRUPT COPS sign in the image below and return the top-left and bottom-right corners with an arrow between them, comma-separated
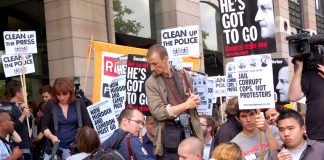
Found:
272,58 -> 289,104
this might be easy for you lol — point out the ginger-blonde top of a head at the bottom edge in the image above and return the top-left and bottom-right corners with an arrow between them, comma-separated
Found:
212,142 -> 244,160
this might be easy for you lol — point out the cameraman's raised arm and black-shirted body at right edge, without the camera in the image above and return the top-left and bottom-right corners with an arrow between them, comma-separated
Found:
289,58 -> 324,141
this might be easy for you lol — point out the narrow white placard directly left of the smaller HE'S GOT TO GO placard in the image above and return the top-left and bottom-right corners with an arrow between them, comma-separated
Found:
110,76 -> 126,116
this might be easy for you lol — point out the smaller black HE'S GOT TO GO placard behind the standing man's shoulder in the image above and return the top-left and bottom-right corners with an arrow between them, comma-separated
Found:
126,54 -> 151,115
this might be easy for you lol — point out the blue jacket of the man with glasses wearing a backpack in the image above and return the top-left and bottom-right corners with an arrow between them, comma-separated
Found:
100,128 -> 153,160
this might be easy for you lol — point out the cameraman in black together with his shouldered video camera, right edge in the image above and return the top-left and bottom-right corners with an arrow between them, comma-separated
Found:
286,33 -> 324,141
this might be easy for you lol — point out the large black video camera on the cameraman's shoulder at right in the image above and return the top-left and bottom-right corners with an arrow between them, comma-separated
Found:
286,30 -> 324,69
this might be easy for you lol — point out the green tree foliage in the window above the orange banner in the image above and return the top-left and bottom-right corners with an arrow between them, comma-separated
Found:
113,0 -> 144,36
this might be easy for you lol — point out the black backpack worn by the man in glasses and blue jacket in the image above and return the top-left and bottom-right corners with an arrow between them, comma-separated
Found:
84,132 -> 135,160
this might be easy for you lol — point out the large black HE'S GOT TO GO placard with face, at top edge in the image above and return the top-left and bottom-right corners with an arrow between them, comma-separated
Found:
219,0 -> 277,57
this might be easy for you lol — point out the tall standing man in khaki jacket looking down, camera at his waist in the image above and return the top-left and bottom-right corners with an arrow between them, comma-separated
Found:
145,44 -> 203,160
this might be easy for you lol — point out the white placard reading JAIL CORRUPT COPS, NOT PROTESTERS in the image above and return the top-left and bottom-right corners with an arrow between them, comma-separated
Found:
234,54 -> 274,109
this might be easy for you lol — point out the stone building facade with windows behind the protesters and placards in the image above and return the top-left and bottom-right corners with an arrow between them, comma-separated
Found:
0,0 -> 324,104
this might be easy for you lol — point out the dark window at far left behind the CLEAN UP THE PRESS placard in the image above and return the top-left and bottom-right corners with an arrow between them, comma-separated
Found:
0,0 -> 49,103
